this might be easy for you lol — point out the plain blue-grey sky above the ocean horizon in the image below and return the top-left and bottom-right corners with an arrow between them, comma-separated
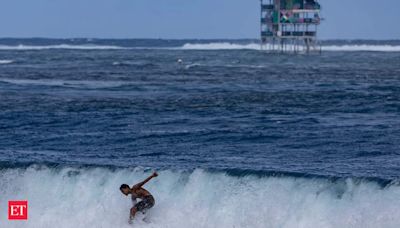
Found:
0,0 -> 400,39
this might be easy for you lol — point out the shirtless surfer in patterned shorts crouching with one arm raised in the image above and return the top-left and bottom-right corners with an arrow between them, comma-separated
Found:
119,172 -> 158,223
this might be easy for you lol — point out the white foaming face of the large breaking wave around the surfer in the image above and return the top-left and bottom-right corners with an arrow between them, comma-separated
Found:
0,166 -> 400,228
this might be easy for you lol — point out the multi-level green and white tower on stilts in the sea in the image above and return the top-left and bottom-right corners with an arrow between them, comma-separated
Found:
260,0 -> 321,53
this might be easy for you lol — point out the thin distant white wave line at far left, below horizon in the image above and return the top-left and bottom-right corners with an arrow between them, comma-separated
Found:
0,44 -> 129,50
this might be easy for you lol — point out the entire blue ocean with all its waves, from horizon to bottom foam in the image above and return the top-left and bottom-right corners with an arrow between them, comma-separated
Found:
0,38 -> 400,228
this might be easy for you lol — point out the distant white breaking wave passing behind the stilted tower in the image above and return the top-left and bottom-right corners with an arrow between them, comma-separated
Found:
181,42 -> 400,52
